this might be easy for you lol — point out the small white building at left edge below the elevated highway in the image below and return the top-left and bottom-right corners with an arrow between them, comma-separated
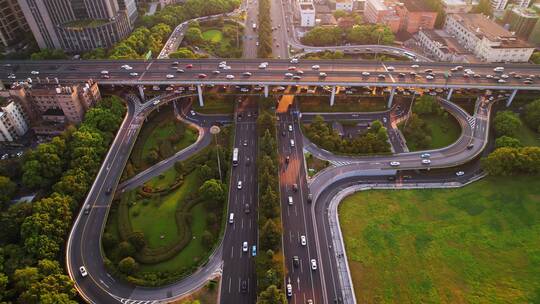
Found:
0,99 -> 28,142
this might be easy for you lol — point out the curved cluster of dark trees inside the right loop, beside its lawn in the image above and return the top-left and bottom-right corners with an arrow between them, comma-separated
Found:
304,115 -> 390,154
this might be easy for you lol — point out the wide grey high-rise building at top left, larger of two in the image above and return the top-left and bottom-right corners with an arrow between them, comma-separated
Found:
19,0 -> 137,52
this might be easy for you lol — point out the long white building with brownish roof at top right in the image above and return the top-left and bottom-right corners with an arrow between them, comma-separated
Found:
444,14 -> 534,62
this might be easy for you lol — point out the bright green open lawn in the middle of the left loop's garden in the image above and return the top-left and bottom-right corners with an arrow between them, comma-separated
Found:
129,172 -> 199,248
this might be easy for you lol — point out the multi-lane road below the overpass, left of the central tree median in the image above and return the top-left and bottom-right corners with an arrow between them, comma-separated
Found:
220,100 -> 259,304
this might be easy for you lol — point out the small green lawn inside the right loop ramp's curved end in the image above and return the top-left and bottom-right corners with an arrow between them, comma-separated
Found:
407,115 -> 461,151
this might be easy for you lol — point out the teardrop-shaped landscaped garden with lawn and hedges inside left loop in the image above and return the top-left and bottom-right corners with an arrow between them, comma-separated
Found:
102,127 -> 232,286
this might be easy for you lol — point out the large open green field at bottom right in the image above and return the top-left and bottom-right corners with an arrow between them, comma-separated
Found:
339,176 -> 540,303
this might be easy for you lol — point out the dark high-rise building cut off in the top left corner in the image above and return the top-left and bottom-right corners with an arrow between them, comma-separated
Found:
0,0 -> 28,46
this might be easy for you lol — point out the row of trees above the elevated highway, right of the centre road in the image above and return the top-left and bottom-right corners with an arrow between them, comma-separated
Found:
302,24 -> 395,46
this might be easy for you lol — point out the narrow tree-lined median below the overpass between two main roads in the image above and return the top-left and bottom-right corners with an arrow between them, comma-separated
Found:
255,98 -> 287,304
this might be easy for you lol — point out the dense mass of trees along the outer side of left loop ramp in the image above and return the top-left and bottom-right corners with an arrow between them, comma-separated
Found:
0,97 -> 125,303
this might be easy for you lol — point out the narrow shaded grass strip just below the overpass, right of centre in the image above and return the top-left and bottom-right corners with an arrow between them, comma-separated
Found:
296,96 -> 386,112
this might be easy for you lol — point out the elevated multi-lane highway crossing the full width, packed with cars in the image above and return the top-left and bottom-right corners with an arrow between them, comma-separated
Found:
0,59 -> 540,90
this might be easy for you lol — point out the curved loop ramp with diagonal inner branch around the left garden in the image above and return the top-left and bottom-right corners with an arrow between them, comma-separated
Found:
66,95 -> 228,303
